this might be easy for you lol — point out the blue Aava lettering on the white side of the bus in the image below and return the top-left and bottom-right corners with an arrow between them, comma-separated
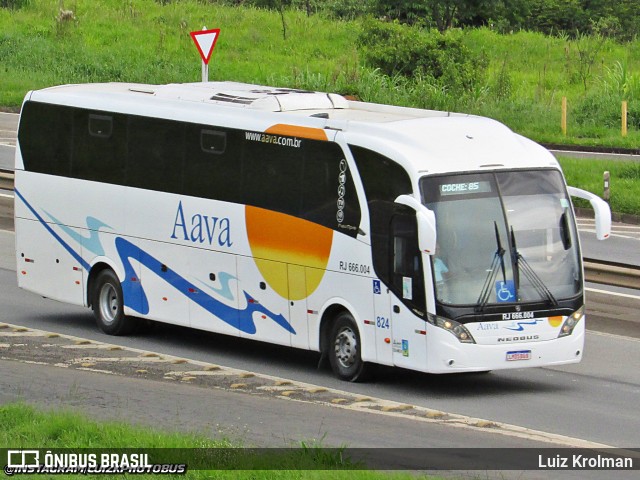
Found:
171,202 -> 233,247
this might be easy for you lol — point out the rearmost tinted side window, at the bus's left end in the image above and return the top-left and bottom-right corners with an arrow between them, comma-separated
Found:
18,102 -> 73,176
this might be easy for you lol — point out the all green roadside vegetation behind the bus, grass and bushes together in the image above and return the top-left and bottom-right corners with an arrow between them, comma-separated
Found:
0,0 -> 640,214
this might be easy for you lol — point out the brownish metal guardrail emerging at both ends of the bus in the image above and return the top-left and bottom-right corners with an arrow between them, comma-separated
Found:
0,169 -> 640,290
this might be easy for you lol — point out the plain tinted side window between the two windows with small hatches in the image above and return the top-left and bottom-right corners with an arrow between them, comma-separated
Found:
127,116 -> 185,193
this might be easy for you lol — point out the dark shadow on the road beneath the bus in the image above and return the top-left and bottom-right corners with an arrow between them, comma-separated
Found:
16,312 -> 572,399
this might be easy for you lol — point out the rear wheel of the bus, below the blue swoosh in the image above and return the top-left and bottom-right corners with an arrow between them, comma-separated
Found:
91,269 -> 135,335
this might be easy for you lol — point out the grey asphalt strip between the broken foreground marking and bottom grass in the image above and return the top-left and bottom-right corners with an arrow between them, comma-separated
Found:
0,360 -> 638,480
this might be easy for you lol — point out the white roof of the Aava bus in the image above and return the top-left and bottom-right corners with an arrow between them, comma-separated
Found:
32,82 -> 557,176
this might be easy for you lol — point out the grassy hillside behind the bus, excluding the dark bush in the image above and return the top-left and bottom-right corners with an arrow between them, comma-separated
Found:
0,0 -> 640,148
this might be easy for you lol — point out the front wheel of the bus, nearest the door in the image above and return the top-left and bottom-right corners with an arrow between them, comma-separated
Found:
327,312 -> 369,382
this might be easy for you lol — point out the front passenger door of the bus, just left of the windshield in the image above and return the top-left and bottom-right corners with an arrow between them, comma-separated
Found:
389,211 -> 427,370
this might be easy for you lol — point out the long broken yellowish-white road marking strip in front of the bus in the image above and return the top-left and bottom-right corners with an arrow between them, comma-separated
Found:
0,323 -> 613,449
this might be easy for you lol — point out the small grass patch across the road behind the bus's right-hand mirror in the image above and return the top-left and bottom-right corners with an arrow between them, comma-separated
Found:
558,157 -> 640,215
